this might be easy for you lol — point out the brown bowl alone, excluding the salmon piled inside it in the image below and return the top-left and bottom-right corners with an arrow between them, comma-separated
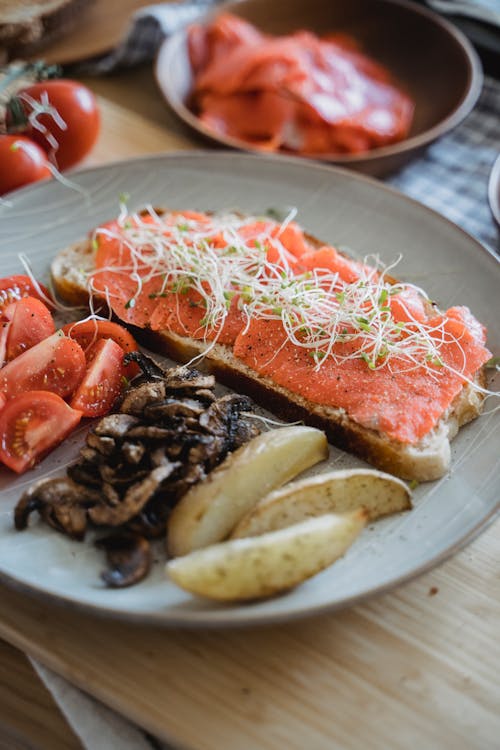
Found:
156,0 -> 482,176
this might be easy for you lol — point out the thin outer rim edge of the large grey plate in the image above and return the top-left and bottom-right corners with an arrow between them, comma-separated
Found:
0,149 -> 500,629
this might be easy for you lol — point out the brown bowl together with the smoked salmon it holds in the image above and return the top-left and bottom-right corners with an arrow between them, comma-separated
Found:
156,0 -> 482,176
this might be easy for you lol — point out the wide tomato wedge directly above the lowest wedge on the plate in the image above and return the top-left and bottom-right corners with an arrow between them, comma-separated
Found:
0,331 -> 85,398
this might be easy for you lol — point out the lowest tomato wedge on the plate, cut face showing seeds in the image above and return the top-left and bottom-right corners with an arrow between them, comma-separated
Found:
0,391 -> 82,474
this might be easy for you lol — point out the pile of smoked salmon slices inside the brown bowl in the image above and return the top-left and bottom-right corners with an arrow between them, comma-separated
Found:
188,14 -> 414,154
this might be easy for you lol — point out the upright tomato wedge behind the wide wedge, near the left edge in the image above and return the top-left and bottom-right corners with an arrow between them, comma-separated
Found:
3,297 -> 56,361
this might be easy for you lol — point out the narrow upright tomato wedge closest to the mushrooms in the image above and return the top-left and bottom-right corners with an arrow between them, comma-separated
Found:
71,339 -> 125,417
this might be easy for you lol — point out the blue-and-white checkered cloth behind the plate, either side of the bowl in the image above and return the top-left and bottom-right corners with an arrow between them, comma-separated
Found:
76,0 -> 500,250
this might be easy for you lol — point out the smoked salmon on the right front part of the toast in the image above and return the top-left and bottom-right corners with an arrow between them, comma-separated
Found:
233,308 -> 491,443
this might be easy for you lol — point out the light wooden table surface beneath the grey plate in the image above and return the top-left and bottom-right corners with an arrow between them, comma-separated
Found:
0,68 -> 500,750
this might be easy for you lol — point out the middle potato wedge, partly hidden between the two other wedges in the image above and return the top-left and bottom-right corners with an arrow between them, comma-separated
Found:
231,469 -> 411,539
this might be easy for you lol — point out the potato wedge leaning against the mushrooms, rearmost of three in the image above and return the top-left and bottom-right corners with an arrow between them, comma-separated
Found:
167,426 -> 328,556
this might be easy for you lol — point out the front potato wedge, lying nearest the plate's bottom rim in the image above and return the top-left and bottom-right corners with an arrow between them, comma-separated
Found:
166,510 -> 366,601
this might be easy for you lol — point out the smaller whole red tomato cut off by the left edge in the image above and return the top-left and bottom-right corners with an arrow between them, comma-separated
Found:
0,135 -> 51,195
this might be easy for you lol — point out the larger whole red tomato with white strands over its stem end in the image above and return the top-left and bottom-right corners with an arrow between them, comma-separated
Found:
11,80 -> 100,171
